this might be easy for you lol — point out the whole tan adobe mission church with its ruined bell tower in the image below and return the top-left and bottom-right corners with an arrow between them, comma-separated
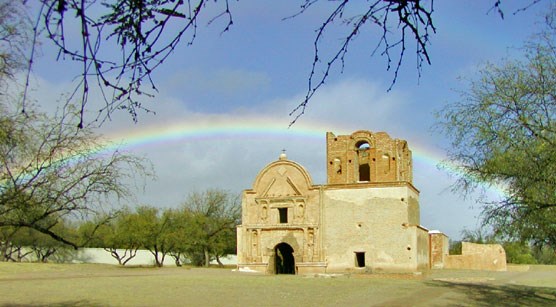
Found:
237,131 -> 440,274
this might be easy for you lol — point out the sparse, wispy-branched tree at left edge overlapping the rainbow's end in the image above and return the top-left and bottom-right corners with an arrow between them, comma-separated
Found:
0,101 -> 150,247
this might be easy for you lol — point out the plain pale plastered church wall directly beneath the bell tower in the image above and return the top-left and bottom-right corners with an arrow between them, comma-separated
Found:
322,187 -> 422,272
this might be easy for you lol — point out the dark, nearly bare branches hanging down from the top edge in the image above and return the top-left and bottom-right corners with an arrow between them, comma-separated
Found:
13,0 -> 540,127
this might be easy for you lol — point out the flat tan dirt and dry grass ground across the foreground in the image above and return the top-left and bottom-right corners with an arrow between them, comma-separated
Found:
0,263 -> 556,306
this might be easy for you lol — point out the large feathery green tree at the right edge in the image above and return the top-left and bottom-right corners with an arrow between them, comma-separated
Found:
439,9 -> 556,250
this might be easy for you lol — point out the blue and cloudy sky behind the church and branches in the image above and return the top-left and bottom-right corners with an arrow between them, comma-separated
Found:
23,0 -> 550,239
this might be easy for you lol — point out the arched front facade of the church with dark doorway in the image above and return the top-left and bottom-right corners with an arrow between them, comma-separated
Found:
237,155 -> 324,273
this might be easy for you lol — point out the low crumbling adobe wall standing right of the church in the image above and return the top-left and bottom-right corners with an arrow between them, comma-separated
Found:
444,242 -> 507,271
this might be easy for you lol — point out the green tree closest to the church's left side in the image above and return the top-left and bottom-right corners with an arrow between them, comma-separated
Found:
183,189 -> 241,267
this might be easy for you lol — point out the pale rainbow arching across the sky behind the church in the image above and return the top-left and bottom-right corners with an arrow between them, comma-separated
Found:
101,116 -> 506,200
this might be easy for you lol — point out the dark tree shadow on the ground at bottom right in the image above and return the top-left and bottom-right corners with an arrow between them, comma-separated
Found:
427,281 -> 556,306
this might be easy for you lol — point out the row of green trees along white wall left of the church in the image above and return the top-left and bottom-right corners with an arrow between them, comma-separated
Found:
0,190 -> 241,267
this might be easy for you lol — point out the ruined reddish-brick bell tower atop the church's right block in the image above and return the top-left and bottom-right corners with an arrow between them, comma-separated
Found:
326,130 -> 413,184
